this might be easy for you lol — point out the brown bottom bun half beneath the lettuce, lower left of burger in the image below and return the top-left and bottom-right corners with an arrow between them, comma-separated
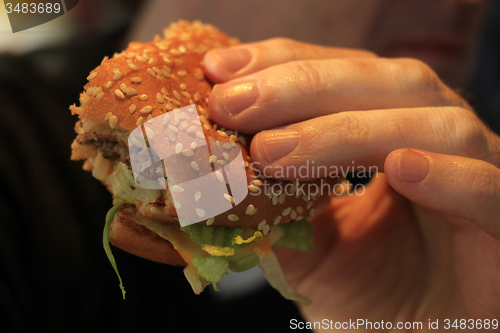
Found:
109,207 -> 187,266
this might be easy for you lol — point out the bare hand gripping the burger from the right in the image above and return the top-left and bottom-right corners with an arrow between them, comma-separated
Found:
204,39 -> 500,331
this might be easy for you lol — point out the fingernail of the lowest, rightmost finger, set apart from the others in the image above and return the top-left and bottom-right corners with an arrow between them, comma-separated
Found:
398,149 -> 429,183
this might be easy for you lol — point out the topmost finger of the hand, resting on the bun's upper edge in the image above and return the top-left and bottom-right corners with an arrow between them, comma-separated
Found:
203,38 -> 376,83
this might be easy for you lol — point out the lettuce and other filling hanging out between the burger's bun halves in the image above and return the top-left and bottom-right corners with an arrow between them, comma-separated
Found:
72,140 -> 313,304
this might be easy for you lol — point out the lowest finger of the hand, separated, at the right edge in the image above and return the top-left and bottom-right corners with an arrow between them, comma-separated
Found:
384,149 -> 500,240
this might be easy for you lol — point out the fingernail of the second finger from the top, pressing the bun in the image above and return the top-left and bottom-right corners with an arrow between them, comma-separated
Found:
212,80 -> 259,116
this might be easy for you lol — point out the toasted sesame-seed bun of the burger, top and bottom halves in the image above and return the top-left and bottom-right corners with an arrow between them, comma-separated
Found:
70,21 -> 336,265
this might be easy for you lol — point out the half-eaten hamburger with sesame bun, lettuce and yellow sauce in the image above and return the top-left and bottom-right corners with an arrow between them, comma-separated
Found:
70,21 -> 334,304
